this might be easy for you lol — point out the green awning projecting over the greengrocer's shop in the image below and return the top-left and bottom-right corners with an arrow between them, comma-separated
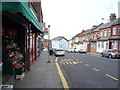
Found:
2,0 -> 43,32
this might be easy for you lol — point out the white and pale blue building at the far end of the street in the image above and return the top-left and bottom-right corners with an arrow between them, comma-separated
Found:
51,36 -> 68,50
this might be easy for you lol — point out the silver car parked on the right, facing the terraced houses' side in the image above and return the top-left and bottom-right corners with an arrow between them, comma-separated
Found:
101,49 -> 120,58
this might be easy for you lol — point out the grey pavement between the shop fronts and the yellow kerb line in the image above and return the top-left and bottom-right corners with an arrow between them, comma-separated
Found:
13,51 -> 63,89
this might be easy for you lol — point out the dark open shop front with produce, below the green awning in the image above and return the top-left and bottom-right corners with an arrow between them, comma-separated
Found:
2,14 -> 25,84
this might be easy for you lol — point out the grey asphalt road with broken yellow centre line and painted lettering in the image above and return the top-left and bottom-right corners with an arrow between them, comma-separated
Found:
58,52 -> 118,88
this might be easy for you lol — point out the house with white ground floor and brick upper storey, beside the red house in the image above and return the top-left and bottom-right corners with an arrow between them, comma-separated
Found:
97,15 -> 117,53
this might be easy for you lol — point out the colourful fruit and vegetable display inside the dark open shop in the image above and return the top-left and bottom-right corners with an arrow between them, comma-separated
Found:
3,27 -> 25,79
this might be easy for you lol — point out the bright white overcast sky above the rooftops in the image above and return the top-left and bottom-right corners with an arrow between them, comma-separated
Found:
41,0 -> 120,40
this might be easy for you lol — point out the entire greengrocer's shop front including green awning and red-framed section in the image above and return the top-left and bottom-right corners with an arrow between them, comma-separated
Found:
2,2 -> 42,85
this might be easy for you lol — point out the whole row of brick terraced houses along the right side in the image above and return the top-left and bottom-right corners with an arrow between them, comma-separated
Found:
72,13 -> 120,53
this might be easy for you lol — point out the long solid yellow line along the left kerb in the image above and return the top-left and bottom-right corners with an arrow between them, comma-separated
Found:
55,57 -> 69,90
